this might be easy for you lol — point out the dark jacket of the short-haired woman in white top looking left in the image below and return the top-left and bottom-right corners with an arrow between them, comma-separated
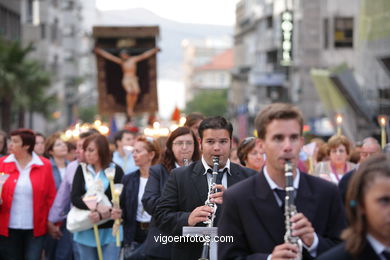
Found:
120,170 -> 141,245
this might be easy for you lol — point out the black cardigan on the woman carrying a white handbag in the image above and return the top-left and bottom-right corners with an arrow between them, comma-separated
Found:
71,165 -> 123,228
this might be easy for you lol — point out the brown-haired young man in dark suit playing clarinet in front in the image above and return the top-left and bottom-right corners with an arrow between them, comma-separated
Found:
218,103 -> 345,260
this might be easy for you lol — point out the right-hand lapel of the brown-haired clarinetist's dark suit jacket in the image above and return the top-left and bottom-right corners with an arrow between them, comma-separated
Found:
295,173 -> 317,222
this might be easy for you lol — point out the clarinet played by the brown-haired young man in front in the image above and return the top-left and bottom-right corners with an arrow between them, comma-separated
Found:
284,161 -> 302,260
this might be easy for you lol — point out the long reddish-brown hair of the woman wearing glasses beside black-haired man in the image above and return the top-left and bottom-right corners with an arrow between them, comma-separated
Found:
161,127 -> 200,172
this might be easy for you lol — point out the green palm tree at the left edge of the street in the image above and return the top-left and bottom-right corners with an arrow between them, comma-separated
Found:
0,38 -> 55,131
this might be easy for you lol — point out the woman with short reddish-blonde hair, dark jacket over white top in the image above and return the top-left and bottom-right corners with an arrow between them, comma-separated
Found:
120,136 -> 160,259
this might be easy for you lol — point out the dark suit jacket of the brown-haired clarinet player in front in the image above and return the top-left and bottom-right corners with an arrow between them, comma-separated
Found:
218,172 -> 346,259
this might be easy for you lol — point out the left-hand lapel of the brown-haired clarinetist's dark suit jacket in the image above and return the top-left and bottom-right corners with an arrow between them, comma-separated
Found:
252,172 -> 285,245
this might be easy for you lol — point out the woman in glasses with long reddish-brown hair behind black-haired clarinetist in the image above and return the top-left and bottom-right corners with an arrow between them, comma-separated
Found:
142,127 -> 200,259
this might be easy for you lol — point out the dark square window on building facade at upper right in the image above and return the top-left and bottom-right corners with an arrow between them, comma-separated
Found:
334,17 -> 353,48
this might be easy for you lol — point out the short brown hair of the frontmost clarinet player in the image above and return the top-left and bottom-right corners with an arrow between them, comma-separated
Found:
255,103 -> 303,139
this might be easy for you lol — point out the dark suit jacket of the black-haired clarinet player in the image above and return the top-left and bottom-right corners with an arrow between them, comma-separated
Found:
154,160 -> 256,260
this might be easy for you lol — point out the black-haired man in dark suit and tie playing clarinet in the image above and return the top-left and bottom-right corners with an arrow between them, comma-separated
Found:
154,116 -> 256,260
